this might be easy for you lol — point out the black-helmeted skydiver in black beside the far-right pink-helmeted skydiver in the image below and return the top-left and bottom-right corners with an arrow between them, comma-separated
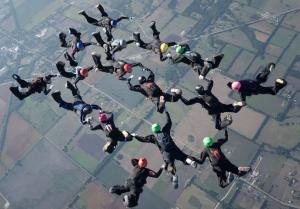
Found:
180,80 -> 244,130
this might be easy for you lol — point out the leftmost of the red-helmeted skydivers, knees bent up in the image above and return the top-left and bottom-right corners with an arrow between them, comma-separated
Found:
56,61 -> 94,86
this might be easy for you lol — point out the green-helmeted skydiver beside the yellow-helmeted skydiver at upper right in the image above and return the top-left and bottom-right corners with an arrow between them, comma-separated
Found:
167,44 -> 224,79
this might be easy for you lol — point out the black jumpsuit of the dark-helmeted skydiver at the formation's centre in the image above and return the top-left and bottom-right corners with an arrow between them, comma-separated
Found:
128,69 -> 180,113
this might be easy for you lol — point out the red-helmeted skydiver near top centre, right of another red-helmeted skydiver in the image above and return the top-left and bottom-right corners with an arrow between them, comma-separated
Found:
92,52 -> 143,80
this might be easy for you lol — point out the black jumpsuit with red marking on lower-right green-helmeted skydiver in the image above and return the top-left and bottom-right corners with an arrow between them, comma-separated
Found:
198,130 -> 245,188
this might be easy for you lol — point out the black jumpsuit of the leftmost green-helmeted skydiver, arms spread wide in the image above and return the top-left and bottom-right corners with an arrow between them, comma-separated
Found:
135,112 -> 194,175
